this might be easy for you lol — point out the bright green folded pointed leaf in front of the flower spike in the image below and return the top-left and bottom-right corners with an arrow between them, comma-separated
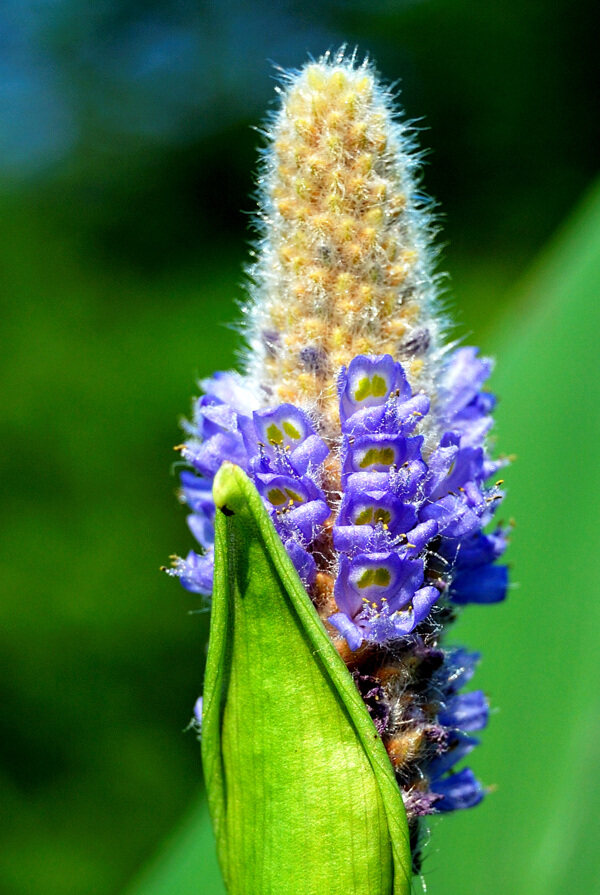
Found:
202,463 -> 411,895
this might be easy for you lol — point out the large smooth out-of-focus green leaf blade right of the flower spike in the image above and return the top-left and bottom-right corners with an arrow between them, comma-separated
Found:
425,177 -> 600,895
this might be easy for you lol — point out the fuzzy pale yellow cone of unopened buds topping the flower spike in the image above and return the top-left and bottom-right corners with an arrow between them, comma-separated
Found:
248,56 -> 437,436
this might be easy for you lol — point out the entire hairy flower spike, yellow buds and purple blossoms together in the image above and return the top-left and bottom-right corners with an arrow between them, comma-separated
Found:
170,55 -> 508,863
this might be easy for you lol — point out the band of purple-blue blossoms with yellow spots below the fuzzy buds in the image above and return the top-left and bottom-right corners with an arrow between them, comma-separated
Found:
171,348 -> 508,817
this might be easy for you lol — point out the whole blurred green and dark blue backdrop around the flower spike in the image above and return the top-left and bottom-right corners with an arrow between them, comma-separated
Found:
0,0 -> 600,895
